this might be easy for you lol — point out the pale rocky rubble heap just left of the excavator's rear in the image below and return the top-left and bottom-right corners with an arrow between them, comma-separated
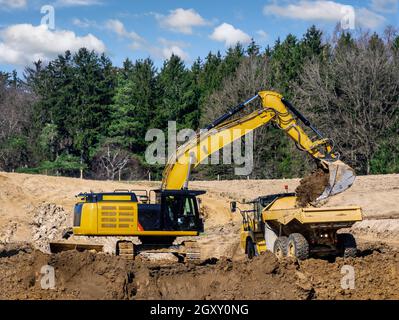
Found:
31,203 -> 69,253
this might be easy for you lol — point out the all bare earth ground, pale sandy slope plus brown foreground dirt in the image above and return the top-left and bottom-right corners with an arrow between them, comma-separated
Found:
0,173 -> 399,299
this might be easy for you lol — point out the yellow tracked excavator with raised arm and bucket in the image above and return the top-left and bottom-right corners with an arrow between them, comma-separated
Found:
50,91 -> 355,260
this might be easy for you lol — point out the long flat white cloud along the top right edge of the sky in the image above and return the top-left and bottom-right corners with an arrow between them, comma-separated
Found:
263,0 -> 385,28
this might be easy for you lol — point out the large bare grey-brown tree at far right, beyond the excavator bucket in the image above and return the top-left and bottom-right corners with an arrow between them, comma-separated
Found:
295,34 -> 399,174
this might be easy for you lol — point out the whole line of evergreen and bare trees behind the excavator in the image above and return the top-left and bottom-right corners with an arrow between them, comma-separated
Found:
0,26 -> 399,180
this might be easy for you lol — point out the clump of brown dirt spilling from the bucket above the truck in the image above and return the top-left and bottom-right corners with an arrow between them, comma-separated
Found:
295,169 -> 329,207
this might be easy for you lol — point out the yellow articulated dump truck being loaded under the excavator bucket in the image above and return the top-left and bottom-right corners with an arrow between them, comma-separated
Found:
230,193 -> 362,260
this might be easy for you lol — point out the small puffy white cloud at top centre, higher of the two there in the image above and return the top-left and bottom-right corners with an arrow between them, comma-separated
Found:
156,8 -> 209,34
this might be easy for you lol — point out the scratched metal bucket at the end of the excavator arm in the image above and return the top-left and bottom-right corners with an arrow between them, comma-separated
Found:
316,160 -> 356,201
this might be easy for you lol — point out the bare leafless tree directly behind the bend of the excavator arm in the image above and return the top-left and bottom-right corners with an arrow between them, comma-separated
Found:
202,56 -> 306,178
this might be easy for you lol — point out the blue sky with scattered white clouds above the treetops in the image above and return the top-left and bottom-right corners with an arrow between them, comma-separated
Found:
0,0 -> 399,71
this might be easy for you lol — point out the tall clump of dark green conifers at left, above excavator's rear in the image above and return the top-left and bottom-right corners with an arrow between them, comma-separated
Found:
27,49 -> 116,168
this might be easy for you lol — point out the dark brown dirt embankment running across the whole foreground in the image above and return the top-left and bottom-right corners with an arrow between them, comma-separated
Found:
0,247 -> 399,300
